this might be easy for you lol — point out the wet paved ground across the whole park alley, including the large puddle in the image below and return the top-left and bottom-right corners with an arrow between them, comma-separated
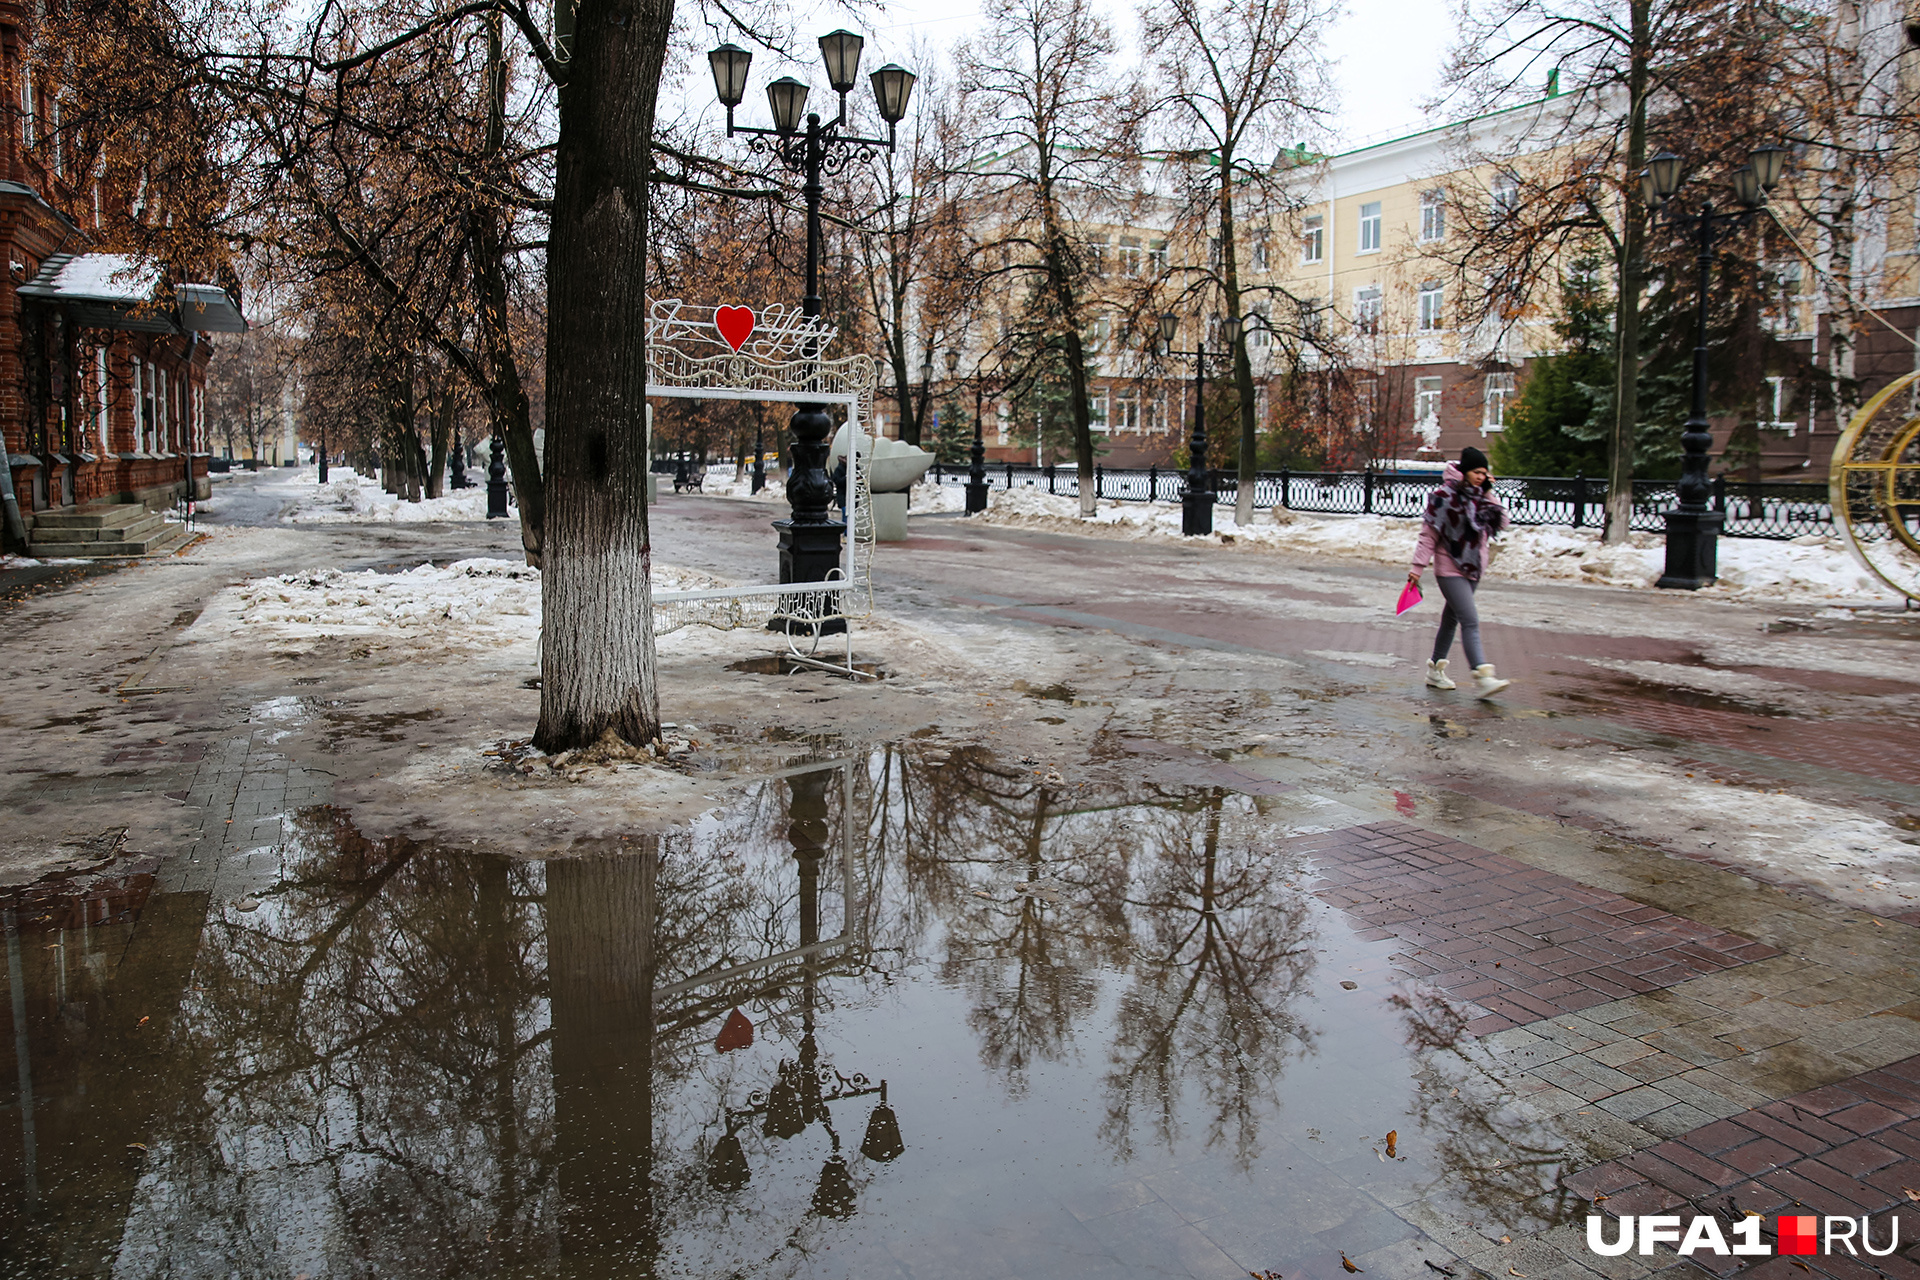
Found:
0,485 -> 1920,1280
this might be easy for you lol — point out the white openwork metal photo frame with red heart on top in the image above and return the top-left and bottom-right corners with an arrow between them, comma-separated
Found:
647,297 -> 879,674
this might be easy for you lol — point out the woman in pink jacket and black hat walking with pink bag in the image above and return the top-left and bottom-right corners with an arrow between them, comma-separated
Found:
1407,445 -> 1513,699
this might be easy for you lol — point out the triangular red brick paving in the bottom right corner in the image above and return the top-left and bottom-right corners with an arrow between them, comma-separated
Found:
1565,1055 -> 1920,1280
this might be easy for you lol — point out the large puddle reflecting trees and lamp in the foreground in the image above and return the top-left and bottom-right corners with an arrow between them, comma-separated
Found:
0,747 -> 1561,1280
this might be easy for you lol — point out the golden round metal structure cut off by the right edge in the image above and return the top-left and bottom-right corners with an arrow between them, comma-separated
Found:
1826,370 -> 1920,601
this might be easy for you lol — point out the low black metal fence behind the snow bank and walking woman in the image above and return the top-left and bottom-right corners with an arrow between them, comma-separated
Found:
931,462 -> 1837,539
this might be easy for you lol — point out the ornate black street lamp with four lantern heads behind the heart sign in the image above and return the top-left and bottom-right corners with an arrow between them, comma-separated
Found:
707,31 -> 916,581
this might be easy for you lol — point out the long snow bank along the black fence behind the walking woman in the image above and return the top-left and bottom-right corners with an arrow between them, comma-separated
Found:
981,489 -> 1899,603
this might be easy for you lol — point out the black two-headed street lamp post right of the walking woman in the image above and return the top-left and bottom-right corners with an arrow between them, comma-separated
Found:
1640,144 -> 1788,591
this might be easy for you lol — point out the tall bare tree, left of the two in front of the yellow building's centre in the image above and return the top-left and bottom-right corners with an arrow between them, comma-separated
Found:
958,0 -> 1140,516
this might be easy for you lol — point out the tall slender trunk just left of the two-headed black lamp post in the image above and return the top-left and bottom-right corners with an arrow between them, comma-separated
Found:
1603,0 -> 1653,543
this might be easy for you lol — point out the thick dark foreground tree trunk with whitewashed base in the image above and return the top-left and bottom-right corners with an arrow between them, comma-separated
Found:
529,0 -> 674,752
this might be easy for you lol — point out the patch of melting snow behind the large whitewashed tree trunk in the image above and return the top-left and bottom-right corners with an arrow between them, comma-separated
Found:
209,560 -> 726,643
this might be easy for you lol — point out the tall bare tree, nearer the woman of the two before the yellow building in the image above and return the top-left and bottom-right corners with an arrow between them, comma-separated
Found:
1144,0 -> 1332,524
